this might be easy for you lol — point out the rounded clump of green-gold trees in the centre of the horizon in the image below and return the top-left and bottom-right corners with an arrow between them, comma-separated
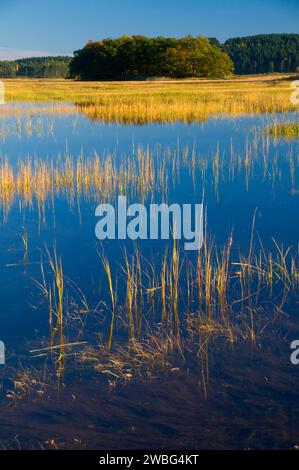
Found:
70,36 -> 234,80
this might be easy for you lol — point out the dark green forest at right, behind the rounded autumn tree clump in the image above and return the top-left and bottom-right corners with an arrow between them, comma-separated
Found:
223,34 -> 299,75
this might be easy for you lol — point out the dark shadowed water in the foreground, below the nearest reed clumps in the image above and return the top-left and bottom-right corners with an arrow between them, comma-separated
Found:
0,326 -> 299,450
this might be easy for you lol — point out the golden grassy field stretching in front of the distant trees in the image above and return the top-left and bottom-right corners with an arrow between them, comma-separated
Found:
5,74 -> 296,123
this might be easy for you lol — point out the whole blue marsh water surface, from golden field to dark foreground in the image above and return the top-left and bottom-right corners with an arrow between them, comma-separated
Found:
0,103 -> 299,449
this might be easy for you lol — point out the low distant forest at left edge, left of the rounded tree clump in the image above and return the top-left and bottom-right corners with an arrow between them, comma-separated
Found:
0,57 -> 71,78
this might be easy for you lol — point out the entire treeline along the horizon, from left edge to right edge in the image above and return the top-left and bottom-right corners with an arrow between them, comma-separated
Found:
0,34 -> 299,80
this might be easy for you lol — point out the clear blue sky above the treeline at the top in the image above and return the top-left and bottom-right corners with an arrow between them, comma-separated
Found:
0,0 -> 299,59
